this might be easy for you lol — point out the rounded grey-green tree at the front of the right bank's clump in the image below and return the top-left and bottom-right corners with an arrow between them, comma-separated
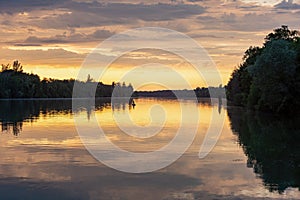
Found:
249,40 -> 297,113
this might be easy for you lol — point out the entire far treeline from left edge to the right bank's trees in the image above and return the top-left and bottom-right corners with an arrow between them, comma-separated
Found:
0,61 -> 225,99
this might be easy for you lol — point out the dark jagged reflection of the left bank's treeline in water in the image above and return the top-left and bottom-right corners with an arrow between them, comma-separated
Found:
0,99 -> 110,136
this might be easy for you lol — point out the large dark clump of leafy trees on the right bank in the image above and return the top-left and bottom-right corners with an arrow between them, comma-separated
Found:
226,26 -> 300,114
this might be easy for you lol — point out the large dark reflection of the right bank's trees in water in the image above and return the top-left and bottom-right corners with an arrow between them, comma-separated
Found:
228,108 -> 300,193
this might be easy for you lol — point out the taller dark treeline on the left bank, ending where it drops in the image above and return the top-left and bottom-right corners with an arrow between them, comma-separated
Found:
0,61 -> 133,98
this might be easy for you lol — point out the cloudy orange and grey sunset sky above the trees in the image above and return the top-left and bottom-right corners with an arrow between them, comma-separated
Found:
0,0 -> 300,89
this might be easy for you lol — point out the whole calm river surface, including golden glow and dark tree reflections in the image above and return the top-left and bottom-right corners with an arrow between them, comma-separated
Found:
0,99 -> 300,199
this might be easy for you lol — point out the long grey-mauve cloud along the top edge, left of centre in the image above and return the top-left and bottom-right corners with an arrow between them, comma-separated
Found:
36,3 -> 204,28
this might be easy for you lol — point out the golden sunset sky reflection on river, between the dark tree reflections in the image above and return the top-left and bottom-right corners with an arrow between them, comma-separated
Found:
0,99 -> 300,199
